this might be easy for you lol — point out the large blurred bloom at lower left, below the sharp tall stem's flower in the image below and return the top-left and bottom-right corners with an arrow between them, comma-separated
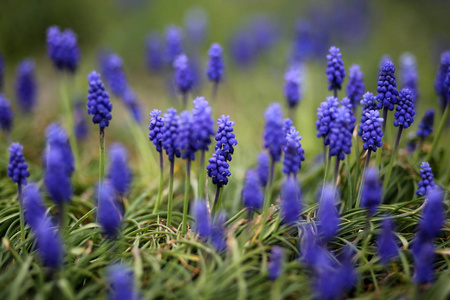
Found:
97,181 -> 122,238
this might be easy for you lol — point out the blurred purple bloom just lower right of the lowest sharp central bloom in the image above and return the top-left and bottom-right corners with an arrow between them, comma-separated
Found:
242,170 -> 264,210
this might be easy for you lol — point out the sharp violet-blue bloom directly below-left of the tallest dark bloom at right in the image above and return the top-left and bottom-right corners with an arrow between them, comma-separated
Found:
361,110 -> 383,152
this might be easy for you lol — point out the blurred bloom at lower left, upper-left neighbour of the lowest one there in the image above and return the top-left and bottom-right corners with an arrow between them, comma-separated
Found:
23,184 -> 45,230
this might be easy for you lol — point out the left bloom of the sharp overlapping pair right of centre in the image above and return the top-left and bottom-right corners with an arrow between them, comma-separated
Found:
316,97 -> 339,145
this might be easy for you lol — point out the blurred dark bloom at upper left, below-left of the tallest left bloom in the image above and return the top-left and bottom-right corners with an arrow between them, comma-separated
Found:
16,59 -> 37,113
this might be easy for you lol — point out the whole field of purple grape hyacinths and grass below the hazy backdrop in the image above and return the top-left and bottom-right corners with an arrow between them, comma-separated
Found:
0,7 -> 450,299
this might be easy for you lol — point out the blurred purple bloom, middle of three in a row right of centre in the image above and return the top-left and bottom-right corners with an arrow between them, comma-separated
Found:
281,177 -> 302,225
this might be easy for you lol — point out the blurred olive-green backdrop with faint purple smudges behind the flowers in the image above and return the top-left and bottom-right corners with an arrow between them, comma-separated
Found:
0,0 -> 450,206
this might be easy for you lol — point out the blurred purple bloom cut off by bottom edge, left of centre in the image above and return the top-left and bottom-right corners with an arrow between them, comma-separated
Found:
108,264 -> 139,300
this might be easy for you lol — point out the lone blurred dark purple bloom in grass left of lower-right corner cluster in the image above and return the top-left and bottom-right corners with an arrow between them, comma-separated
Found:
377,217 -> 399,266
